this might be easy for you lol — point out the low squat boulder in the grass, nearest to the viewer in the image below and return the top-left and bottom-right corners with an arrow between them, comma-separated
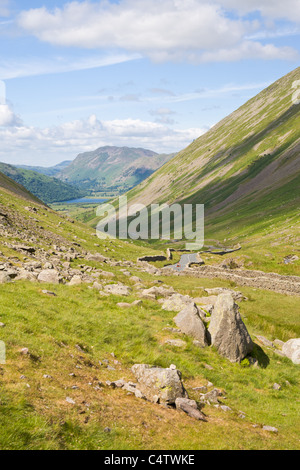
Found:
131,364 -> 188,405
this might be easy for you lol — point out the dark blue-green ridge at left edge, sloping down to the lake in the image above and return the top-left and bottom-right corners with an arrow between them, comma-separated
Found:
0,163 -> 84,204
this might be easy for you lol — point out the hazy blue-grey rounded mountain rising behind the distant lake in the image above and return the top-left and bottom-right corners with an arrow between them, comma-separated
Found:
58,146 -> 174,191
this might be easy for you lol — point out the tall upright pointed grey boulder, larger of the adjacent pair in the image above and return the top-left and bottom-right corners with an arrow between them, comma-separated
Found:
208,294 -> 253,362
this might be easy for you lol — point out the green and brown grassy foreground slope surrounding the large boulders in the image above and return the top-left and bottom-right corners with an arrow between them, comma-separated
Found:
0,183 -> 300,450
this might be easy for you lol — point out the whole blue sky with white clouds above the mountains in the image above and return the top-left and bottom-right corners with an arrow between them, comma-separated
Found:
0,0 -> 300,166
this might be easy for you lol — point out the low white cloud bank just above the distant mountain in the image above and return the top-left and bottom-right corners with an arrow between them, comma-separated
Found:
0,114 -> 207,166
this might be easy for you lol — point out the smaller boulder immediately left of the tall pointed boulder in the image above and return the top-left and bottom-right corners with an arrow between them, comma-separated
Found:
174,304 -> 208,348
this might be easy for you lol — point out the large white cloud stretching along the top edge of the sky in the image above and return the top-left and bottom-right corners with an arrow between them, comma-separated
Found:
18,0 -> 300,63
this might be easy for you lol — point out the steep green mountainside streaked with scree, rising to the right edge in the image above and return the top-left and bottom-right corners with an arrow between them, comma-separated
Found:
128,68 -> 300,264
